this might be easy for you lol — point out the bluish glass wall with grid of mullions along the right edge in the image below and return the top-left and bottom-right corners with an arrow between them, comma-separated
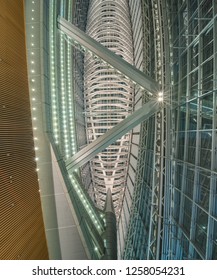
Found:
171,0 -> 217,259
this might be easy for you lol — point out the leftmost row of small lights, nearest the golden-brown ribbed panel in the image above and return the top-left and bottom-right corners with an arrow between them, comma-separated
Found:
30,1 -> 40,179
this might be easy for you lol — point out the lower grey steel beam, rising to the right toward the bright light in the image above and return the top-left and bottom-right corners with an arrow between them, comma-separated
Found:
66,101 -> 160,172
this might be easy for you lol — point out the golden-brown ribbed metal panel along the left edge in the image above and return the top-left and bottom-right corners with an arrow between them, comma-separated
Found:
0,0 -> 48,259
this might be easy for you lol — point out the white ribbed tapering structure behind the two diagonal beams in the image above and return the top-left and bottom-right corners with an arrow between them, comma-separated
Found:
84,0 -> 134,216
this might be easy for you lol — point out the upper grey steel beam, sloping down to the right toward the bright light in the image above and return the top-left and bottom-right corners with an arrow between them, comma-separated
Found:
57,16 -> 160,94
